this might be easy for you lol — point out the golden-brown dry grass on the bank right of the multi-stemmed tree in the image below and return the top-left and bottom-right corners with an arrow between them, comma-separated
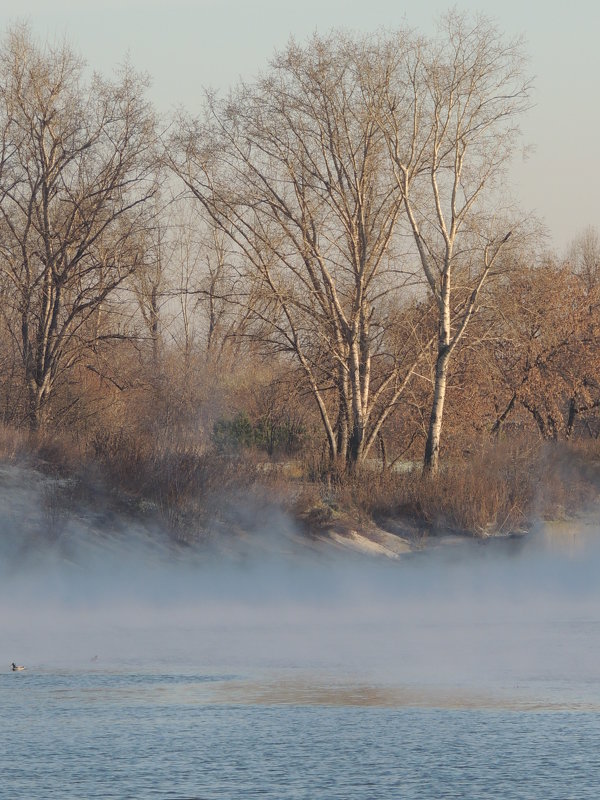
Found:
307,442 -> 600,536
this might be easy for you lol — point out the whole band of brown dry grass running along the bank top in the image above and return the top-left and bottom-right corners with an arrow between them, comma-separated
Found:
0,418 -> 600,541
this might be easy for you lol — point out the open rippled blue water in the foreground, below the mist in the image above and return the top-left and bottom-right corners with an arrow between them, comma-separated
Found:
0,670 -> 600,800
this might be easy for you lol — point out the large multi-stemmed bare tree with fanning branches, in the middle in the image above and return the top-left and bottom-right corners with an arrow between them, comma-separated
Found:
171,34 -> 420,468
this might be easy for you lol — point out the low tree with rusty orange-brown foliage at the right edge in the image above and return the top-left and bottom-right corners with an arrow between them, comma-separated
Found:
488,259 -> 600,440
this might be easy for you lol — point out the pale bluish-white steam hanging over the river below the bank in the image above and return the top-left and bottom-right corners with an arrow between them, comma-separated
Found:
0,462 -> 600,706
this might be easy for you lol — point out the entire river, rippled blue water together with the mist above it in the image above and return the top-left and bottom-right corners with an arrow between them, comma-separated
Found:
0,468 -> 600,800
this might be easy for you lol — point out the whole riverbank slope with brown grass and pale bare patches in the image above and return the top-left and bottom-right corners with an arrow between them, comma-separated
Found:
0,432 -> 600,560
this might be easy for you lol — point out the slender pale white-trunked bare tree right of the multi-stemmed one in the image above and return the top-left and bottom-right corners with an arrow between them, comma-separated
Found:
381,12 -> 530,473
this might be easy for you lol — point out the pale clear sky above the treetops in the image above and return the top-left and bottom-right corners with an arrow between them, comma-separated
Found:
0,0 -> 600,254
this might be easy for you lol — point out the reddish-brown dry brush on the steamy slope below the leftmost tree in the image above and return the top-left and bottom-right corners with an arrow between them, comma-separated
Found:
0,427 -> 262,542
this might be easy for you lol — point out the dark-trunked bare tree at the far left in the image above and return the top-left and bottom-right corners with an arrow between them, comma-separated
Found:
0,27 -> 155,429
